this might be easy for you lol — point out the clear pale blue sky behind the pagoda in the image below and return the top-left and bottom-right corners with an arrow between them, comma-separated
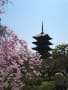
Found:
1,0 -> 68,48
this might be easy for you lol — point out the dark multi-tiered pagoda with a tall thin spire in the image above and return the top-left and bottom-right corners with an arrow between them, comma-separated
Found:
32,23 -> 52,59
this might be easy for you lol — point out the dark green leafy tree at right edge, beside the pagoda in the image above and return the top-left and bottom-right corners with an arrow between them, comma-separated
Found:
52,44 -> 68,71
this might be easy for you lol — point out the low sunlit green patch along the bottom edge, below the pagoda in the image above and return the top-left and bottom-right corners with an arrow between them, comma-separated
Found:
24,81 -> 55,90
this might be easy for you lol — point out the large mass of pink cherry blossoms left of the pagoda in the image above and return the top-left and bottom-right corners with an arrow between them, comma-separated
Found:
0,26 -> 42,90
